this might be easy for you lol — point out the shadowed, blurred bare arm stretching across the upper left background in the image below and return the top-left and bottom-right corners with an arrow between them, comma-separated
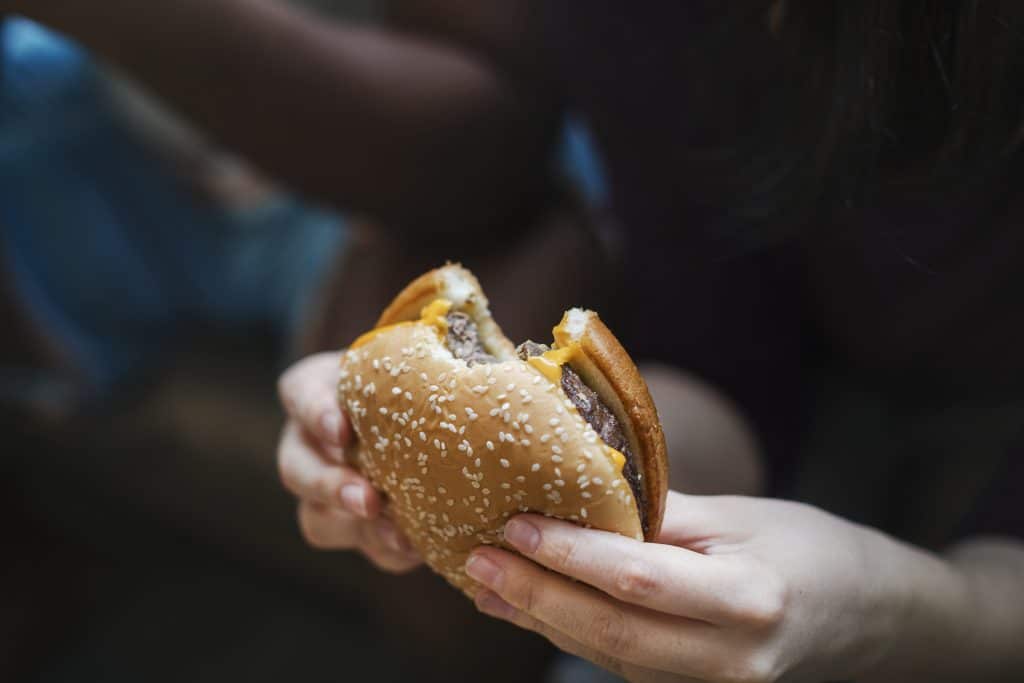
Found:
14,0 -> 557,237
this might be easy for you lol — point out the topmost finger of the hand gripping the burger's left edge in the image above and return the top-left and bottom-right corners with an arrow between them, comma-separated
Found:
278,353 -> 351,454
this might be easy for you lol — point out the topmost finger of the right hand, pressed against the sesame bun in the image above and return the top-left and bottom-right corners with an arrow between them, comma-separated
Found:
505,515 -> 744,624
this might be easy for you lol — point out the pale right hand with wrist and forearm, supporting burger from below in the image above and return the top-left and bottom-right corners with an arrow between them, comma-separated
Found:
466,494 -> 1024,683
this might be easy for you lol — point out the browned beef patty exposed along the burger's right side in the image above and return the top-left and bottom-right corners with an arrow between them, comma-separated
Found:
516,341 -> 647,536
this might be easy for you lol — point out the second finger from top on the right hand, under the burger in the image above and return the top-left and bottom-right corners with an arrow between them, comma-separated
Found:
466,547 -> 722,678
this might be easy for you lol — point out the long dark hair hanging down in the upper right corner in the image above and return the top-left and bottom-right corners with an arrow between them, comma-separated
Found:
700,0 -> 1024,229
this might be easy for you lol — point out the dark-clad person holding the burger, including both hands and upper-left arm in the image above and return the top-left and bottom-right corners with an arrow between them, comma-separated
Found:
8,0 -> 1024,681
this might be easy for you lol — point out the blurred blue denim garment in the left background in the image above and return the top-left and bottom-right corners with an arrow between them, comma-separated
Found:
0,18 -> 345,393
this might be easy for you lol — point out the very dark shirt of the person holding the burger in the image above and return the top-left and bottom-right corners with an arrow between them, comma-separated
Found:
540,0 -> 1024,535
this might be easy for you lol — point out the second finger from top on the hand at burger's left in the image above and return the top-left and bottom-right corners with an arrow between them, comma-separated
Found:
278,420 -> 381,519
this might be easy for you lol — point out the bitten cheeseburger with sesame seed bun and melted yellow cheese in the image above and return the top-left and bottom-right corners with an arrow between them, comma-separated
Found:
338,265 -> 668,593
